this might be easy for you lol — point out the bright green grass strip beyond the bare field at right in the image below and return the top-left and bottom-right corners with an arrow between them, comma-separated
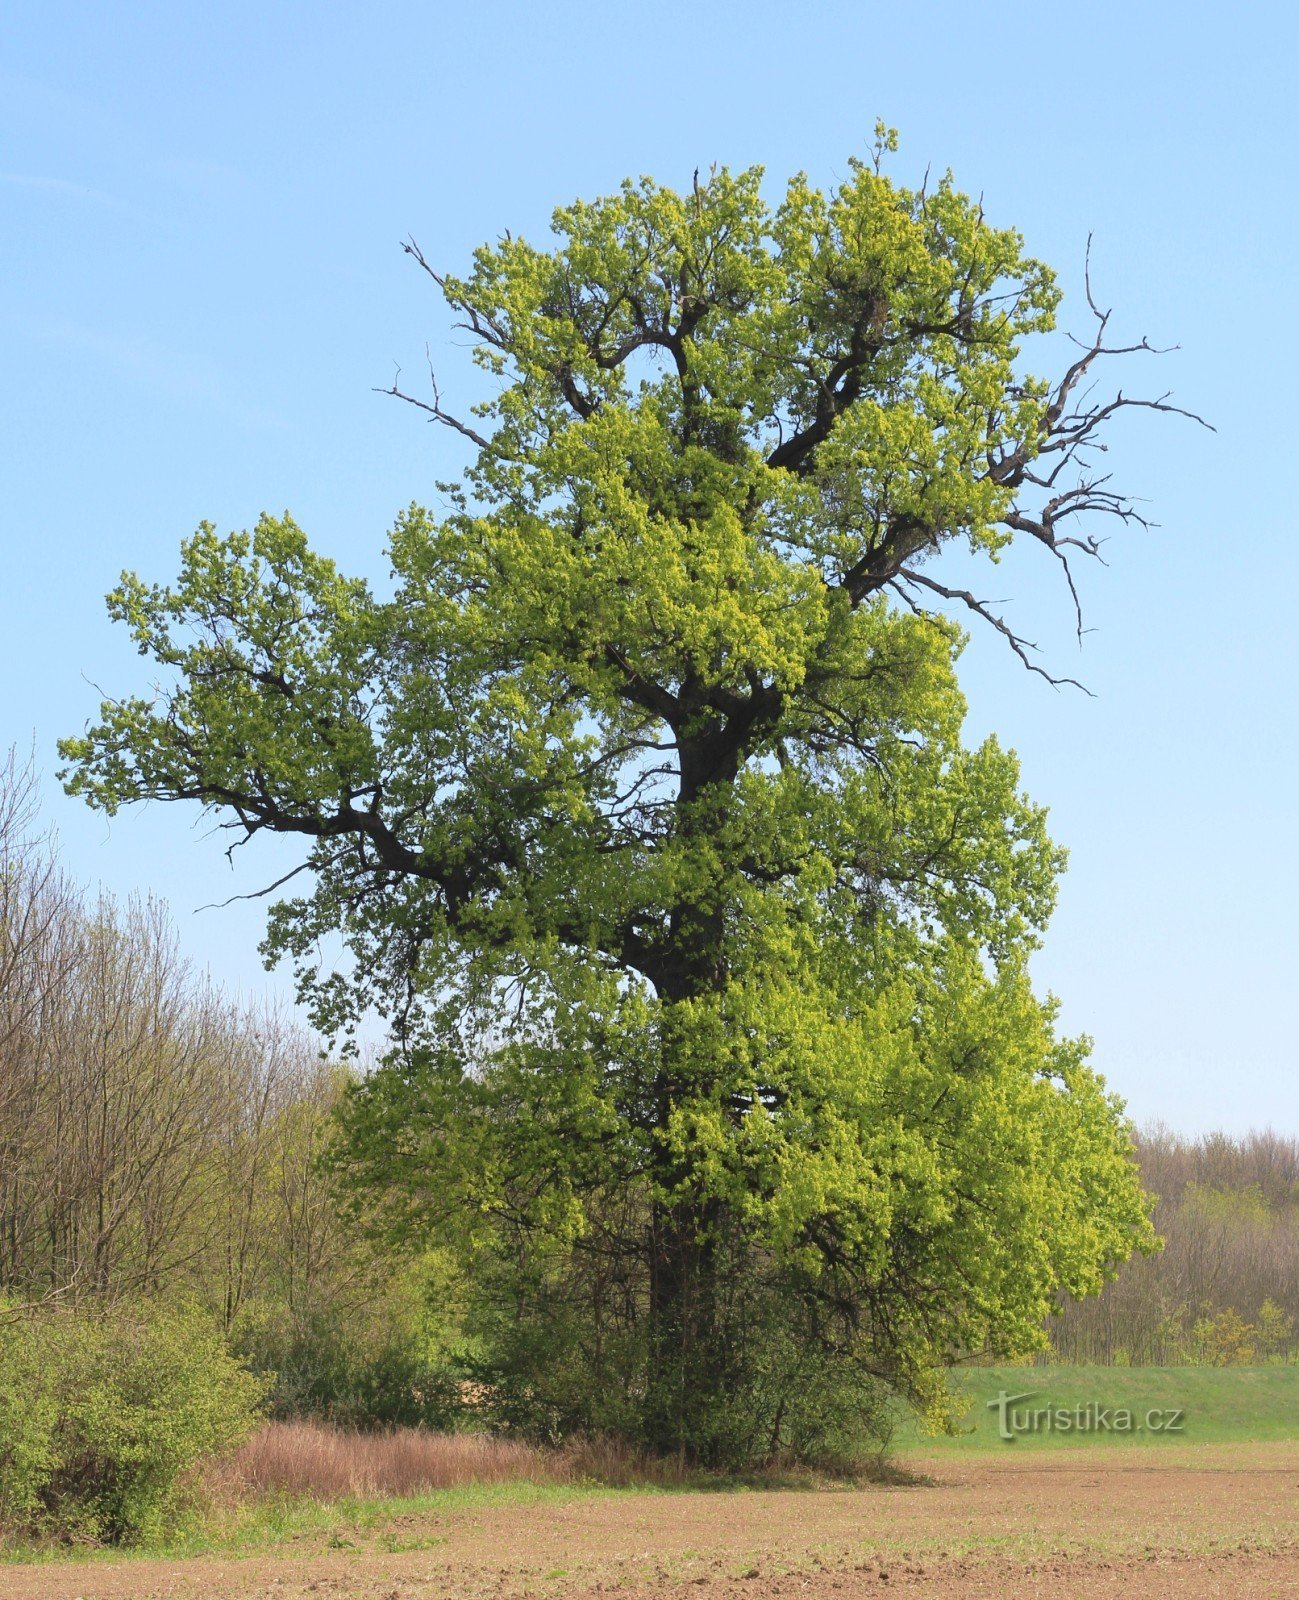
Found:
893,1366 -> 1299,1456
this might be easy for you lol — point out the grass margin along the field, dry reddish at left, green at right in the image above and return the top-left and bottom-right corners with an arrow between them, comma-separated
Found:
10,1366 -> 1299,1562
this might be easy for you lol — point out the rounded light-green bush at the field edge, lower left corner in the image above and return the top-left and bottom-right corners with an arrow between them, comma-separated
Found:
0,1304 -> 264,1544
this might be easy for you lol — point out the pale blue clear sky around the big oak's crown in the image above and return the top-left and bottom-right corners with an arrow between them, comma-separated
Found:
0,0 -> 1299,1133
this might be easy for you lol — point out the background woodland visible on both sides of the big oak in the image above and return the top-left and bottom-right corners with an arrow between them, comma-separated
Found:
0,739 -> 1299,1426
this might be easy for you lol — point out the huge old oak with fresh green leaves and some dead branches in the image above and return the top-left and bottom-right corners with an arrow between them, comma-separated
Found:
62,130 -> 1166,1459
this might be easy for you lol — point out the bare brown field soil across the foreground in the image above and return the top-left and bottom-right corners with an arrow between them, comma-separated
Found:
0,1445 -> 1299,1600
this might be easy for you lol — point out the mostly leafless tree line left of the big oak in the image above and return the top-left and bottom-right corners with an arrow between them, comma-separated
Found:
0,752 -> 457,1421
